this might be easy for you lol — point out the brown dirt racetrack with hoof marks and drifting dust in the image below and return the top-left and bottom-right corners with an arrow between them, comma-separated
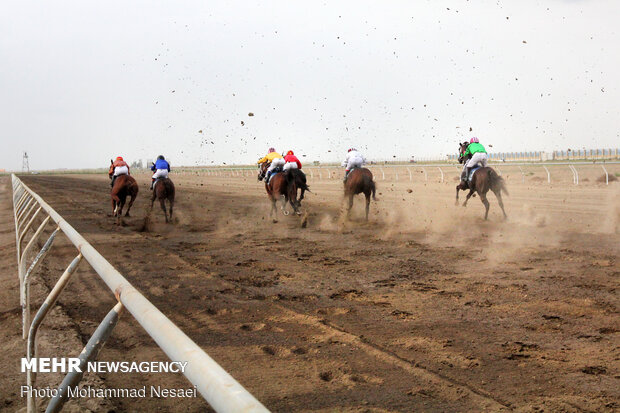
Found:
0,168 -> 620,412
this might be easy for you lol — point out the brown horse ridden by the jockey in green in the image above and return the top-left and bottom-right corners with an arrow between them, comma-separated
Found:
456,142 -> 508,220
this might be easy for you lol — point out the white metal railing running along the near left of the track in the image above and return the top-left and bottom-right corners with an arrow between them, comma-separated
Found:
12,175 -> 268,412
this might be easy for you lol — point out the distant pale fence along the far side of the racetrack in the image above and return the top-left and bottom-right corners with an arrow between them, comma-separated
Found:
176,161 -> 620,185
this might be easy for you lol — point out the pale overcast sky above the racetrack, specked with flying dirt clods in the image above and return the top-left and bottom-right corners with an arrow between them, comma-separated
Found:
0,0 -> 620,170
